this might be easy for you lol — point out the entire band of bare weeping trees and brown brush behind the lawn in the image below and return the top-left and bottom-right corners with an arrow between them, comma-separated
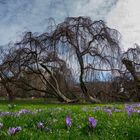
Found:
0,17 -> 140,103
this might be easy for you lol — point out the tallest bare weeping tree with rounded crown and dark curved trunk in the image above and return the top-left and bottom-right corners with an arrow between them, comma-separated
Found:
51,17 -> 120,102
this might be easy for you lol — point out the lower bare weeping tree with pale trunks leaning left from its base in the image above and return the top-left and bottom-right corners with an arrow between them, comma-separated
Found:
11,32 -> 77,102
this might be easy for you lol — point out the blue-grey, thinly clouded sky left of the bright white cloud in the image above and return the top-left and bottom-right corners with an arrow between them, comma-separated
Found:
0,0 -> 118,45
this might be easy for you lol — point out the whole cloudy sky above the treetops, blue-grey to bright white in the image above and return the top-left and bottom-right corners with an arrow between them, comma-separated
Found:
0,0 -> 140,48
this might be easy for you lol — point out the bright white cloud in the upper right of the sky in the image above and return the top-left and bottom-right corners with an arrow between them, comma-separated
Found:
107,0 -> 140,49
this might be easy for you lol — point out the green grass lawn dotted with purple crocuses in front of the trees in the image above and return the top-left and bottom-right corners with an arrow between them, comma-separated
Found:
0,101 -> 140,140
